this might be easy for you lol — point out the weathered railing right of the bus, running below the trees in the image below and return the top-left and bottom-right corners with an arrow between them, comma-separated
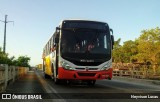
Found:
113,63 -> 160,80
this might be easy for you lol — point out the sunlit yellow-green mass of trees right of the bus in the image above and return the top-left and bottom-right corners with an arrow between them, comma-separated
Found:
113,27 -> 160,75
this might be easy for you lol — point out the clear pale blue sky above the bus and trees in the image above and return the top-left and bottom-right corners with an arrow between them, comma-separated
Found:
0,0 -> 160,66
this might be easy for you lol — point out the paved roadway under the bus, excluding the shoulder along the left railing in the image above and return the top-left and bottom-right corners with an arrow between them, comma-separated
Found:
36,71 -> 160,102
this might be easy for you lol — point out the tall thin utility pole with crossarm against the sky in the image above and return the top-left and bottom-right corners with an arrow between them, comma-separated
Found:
0,15 -> 14,53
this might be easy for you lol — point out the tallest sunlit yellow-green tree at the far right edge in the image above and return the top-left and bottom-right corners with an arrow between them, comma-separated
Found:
137,27 -> 160,64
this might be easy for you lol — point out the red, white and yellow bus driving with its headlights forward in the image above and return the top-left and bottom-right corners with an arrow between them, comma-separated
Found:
42,20 -> 114,85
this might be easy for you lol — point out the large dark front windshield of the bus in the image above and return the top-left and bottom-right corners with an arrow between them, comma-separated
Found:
60,28 -> 111,62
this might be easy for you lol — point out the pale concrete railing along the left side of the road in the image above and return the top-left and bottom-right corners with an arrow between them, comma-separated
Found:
0,64 -> 29,92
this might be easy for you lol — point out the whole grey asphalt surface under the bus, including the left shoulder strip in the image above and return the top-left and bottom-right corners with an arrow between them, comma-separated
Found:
0,70 -> 160,102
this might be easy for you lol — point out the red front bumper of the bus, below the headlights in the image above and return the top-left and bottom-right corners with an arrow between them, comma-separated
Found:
58,67 -> 113,80
